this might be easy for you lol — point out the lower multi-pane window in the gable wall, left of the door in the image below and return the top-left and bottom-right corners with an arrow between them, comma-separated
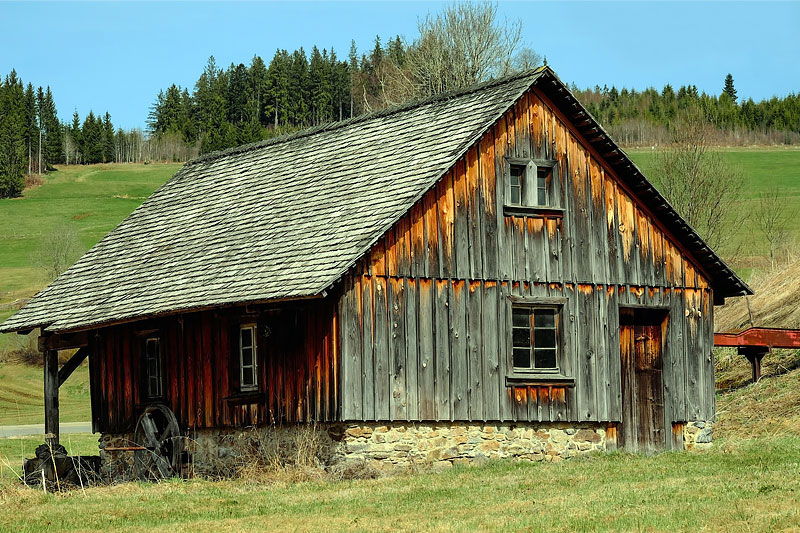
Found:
511,305 -> 560,373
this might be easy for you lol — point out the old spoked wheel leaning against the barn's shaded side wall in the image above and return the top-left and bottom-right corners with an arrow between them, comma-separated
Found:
133,404 -> 183,480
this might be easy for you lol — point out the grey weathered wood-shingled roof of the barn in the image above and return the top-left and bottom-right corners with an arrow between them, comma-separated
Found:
0,67 -> 749,332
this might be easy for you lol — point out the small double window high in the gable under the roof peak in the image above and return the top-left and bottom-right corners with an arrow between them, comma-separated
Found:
504,158 -> 559,216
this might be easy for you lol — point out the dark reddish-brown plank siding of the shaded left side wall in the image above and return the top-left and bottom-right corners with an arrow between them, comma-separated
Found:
90,300 -> 340,432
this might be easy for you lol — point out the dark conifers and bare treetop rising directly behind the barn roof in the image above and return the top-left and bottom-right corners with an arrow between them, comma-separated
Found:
147,3 -> 540,153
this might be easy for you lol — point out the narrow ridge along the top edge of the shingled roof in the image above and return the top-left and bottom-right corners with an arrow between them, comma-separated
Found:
184,66 -> 551,167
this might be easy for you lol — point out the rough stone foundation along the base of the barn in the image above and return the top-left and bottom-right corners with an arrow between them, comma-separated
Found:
101,422 -> 615,480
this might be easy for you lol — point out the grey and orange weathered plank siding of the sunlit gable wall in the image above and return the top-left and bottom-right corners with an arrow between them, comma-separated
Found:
337,89 -> 714,423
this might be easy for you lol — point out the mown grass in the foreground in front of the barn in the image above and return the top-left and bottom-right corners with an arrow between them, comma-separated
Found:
0,438 -> 800,532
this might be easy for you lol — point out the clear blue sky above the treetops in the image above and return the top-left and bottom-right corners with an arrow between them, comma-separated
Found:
0,1 -> 800,128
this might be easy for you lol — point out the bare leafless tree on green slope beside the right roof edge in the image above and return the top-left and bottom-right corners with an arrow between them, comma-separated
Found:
653,110 -> 746,258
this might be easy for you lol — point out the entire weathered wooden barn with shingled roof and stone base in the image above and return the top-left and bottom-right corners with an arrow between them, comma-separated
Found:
0,67 -> 750,471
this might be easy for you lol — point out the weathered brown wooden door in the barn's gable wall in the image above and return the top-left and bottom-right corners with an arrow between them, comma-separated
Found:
617,309 -> 666,454
